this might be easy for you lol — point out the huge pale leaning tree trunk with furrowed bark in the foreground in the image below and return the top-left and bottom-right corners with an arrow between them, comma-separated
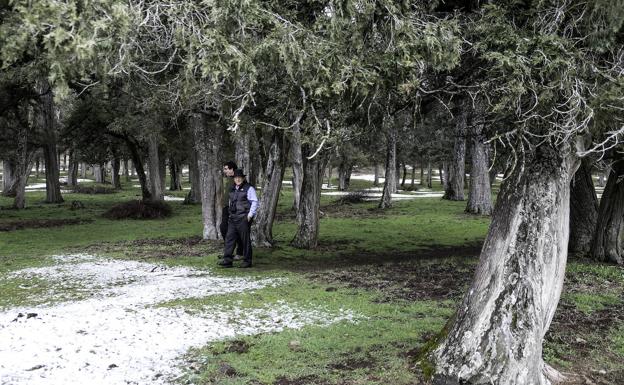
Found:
431,144 -> 578,385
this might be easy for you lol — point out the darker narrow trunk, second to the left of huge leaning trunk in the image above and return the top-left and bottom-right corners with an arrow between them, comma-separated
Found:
442,102 -> 469,201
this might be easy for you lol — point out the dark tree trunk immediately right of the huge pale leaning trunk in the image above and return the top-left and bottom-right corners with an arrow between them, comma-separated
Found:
568,158 -> 598,255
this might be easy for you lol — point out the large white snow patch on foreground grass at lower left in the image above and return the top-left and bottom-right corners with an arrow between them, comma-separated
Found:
0,255 -> 354,385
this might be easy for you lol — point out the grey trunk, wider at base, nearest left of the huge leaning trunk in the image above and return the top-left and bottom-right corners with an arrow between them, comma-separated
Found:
466,116 -> 494,215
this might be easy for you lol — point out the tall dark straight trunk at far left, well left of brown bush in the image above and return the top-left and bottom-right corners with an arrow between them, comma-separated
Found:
38,79 -> 63,203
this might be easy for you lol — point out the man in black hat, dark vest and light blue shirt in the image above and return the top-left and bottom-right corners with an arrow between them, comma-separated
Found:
219,169 -> 258,268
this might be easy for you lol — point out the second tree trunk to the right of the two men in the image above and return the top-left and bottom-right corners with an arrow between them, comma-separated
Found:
291,148 -> 323,249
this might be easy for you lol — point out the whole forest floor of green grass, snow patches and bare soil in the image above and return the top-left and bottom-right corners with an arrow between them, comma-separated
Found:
0,172 -> 624,385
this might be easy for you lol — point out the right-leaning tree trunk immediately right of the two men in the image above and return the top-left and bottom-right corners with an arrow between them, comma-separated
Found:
251,131 -> 286,247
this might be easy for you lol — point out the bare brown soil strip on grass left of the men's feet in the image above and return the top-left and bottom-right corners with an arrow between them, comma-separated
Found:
79,236 -> 223,259
